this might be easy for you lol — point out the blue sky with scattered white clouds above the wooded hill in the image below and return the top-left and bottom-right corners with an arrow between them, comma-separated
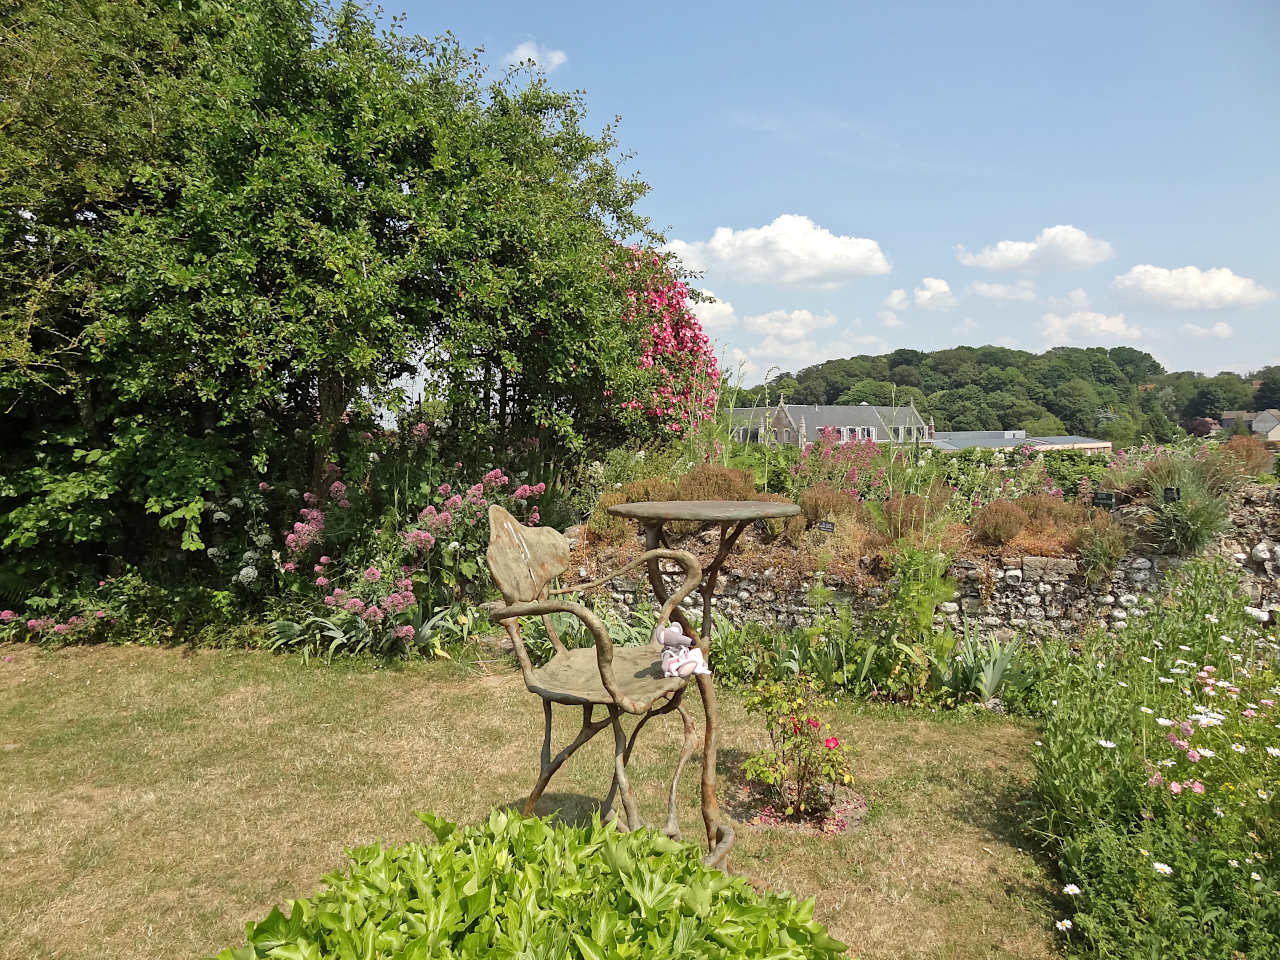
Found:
389,0 -> 1280,383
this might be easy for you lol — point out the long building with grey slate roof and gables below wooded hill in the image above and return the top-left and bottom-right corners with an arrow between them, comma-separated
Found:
731,403 -> 933,447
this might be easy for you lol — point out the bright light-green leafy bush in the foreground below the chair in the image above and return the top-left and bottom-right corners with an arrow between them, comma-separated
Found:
209,810 -> 846,960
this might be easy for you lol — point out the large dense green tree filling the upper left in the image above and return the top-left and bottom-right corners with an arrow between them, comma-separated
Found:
0,0 -> 678,586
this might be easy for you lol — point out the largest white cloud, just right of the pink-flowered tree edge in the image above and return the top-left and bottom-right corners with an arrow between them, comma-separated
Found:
669,214 -> 890,289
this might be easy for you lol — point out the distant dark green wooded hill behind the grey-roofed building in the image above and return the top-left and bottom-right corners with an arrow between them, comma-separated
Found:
736,347 -> 1280,443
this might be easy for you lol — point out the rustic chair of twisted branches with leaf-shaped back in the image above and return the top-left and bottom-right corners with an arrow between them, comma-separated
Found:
485,506 -> 701,838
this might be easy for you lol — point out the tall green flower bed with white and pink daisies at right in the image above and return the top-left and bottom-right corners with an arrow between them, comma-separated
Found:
1030,561 -> 1280,960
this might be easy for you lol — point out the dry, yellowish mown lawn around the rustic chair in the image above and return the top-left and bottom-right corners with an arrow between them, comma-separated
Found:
0,645 -> 1057,960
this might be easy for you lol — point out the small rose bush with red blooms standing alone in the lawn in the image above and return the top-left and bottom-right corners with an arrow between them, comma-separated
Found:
742,677 -> 854,817
